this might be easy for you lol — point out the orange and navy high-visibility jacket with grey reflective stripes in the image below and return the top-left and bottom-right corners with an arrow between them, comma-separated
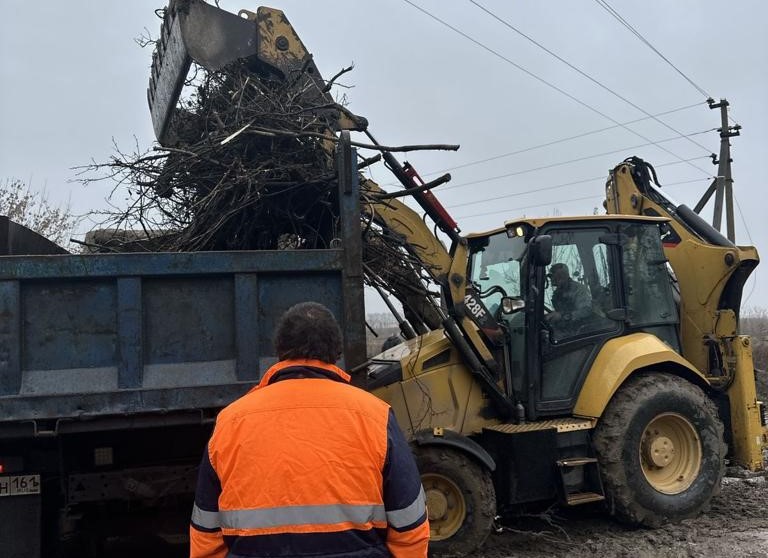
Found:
190,360 -> 429,558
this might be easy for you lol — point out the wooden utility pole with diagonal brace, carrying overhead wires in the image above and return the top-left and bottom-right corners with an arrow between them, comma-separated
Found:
693,98 -> 741,243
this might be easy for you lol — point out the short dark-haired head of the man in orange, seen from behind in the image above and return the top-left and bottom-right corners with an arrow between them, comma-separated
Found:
275,302 -> 342,364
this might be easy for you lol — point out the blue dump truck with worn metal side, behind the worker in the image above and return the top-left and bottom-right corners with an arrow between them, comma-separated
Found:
0,138 -> 365,558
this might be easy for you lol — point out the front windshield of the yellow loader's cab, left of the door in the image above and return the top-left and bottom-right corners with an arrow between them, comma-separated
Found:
469,232 -> 526,314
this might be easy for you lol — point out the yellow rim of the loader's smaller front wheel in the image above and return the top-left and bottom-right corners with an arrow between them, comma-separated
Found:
421,473 -> 467,541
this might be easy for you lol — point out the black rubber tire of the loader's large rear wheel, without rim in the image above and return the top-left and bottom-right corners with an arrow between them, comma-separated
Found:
593,372 -> 726,527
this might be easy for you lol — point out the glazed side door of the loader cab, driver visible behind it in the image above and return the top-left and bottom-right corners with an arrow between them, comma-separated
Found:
527,224 -> 624,416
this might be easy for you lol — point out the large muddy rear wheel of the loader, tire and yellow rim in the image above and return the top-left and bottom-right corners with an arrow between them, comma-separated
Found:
593,373 -> 726,527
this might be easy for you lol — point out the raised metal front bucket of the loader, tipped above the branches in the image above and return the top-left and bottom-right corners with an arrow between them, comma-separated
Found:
147,0 -> 332,145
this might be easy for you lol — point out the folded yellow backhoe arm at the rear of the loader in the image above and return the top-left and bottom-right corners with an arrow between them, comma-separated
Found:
606,157 -> 768,470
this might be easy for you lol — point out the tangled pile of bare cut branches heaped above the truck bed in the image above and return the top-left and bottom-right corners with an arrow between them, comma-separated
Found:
86,63 -> 455,328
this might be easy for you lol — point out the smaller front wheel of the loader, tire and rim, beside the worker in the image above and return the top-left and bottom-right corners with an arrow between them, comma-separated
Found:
414,446 -> 496,558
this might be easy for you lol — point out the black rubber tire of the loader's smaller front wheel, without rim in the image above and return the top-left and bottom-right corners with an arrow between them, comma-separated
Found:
414,446 -> 496,558
